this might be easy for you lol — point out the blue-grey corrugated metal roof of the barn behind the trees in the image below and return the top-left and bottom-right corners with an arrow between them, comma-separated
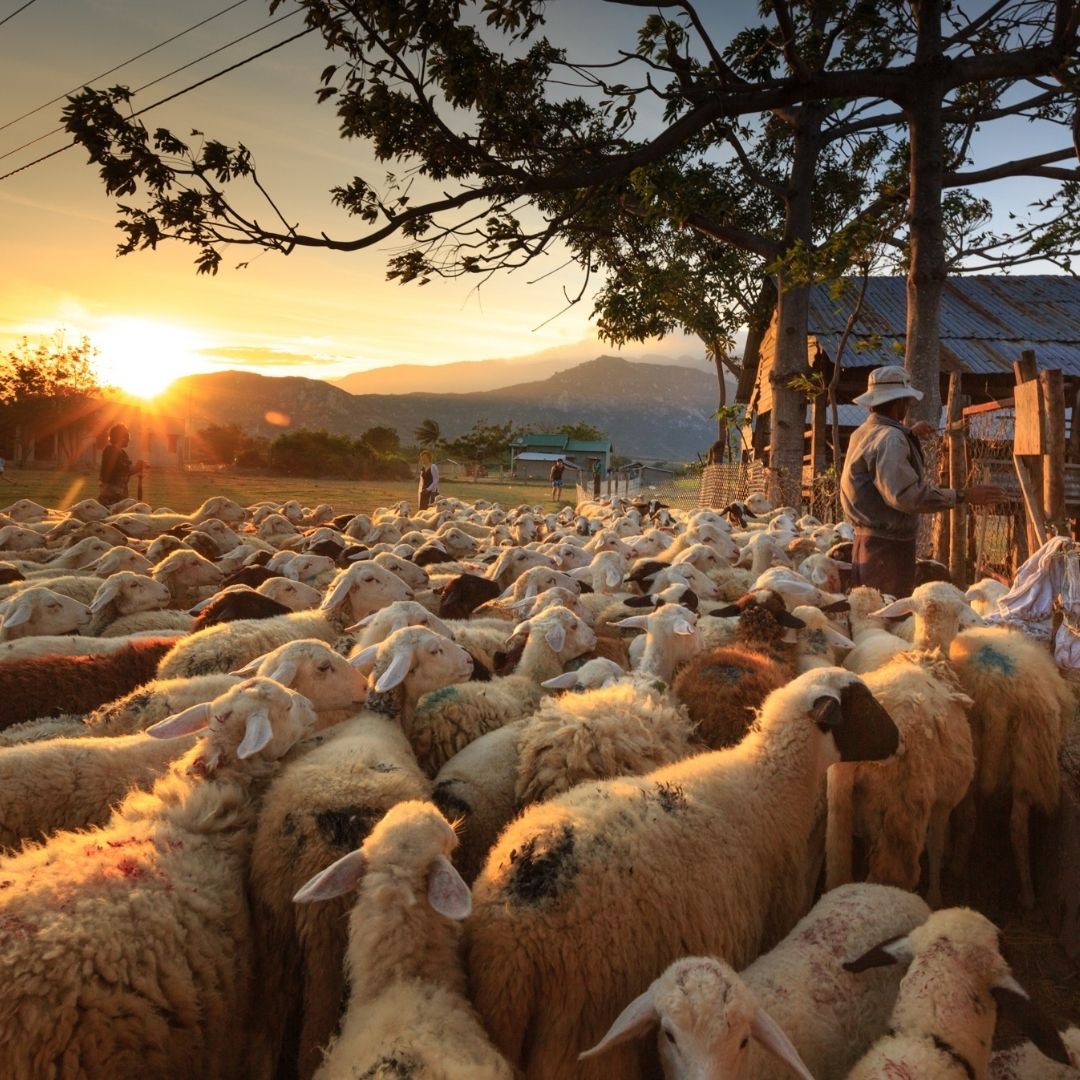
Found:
808,274 -> 1080,375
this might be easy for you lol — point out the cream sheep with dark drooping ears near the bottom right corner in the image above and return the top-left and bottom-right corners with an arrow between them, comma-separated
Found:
846,907 -> 1069,1080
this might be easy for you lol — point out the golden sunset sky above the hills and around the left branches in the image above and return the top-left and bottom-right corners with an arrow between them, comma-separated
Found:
0,0 -> 1067,393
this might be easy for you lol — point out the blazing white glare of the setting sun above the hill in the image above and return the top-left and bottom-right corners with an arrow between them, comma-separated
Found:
94,319 -> 202,397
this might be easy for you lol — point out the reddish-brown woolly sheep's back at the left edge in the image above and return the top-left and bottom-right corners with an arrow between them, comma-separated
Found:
0,637 -> 174,729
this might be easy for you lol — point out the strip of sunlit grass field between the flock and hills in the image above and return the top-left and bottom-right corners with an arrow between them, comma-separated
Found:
0,468 -> 573,513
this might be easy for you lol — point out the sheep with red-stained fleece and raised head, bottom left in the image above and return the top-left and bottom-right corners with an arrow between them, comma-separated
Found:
0,679 -> 314,1080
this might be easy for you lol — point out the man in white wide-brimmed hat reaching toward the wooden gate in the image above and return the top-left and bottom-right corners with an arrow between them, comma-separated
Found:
840,364 -> 1007,597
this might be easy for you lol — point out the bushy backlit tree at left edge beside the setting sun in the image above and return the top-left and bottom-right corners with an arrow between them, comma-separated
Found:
0,332 -> 102,464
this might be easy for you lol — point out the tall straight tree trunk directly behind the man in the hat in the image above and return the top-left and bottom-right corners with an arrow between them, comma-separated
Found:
905,0 -> 946,427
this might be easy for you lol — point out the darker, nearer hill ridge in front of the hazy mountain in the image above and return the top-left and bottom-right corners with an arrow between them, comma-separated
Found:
170,356 -> 716,461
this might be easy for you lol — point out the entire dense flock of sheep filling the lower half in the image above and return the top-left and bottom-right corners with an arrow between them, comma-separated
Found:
0,497 -> 1080,1080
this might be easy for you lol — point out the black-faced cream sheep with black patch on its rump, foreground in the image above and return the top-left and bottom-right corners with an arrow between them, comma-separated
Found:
468,669 -> 897,1080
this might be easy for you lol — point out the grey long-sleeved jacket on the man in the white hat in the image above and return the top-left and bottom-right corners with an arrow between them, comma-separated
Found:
840,413 -> 956,540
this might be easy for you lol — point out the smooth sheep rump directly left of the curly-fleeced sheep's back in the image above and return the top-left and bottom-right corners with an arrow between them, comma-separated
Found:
431,720 -> 527,883
